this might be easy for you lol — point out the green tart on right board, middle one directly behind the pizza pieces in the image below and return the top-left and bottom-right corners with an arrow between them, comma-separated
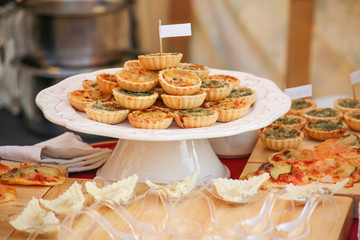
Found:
304,120 -> 347,140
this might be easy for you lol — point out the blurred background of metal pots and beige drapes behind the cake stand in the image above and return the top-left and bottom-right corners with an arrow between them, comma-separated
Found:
0,0 -> 360,145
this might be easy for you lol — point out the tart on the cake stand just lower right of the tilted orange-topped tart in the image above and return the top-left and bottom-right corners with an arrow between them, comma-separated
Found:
201,79 -> 232,101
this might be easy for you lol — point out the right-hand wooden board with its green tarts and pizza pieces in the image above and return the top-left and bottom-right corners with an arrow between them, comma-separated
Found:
240,98 -> 360,218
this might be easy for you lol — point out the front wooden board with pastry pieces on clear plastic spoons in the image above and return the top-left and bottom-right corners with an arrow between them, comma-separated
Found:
0,173 -> 353,239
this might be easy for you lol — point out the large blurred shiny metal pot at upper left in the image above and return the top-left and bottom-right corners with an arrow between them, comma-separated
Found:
18,0 -> 134,67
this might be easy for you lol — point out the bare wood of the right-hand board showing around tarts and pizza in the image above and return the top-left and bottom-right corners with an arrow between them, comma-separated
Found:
246,130 -> 360,218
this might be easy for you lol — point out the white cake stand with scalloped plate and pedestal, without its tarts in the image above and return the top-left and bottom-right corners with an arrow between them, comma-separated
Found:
36,68 -> 291,184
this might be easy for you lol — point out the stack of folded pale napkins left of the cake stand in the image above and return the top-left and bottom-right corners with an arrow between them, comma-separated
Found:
0,132 -> 112,172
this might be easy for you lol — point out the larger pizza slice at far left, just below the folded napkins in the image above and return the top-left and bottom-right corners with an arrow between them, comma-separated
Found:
0,163 -> 66,186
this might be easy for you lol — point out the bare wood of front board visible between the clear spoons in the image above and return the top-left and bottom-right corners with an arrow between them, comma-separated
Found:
5,179 -> 353,240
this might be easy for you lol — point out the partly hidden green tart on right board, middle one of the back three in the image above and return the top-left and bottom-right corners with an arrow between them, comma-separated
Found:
303,108 -> 343,122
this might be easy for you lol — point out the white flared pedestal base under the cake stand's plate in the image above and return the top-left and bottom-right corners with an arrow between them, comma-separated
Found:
96,139 -> 230,184
